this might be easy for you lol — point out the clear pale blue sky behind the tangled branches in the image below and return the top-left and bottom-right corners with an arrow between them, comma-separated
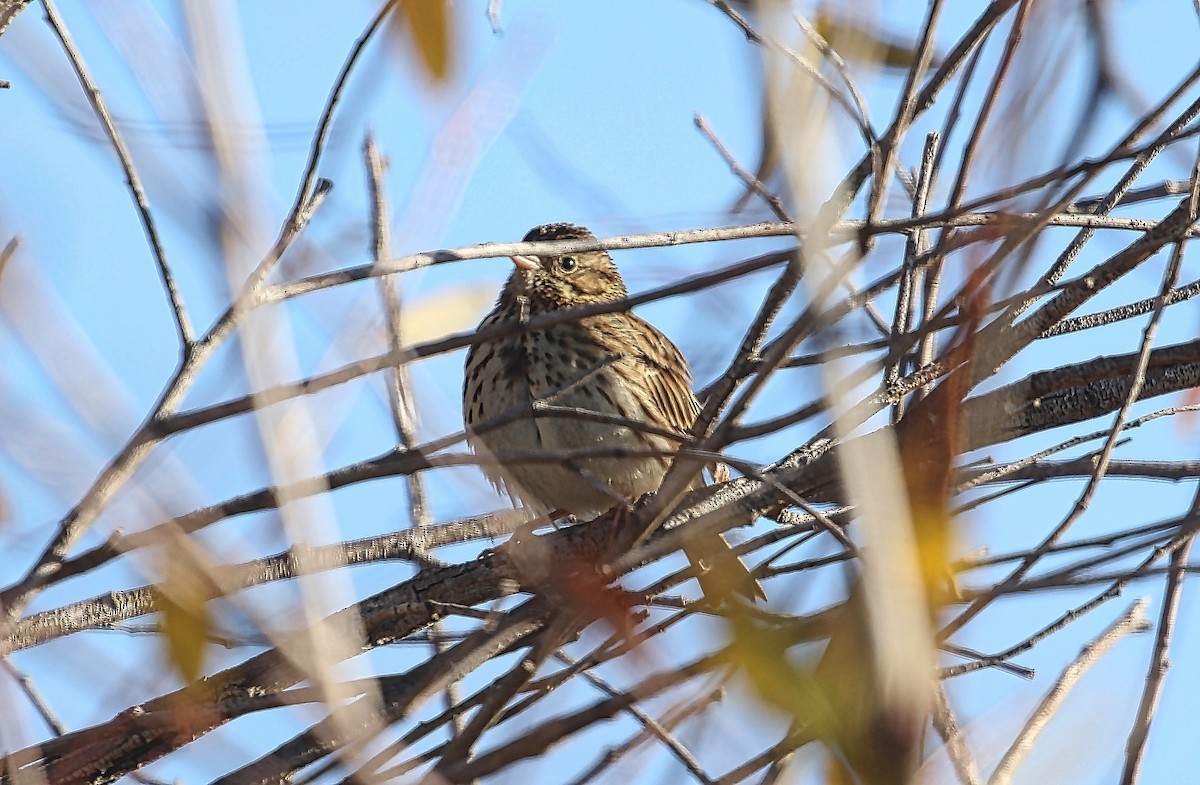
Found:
0,0 -> 1200,783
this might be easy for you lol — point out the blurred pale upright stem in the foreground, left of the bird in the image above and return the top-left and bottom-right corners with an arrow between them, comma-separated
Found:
192,4 -> 382,763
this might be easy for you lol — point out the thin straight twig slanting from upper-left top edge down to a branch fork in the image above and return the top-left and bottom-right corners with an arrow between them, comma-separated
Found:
42,0 -> 194,348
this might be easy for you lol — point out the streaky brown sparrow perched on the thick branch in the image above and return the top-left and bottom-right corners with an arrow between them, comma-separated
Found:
462,223 -> 766,603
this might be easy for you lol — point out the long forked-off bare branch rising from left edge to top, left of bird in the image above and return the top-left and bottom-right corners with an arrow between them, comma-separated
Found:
0,0 -> 396,618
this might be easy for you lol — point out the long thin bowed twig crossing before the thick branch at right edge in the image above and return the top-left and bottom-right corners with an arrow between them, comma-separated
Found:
943,164 -> 1200,635
